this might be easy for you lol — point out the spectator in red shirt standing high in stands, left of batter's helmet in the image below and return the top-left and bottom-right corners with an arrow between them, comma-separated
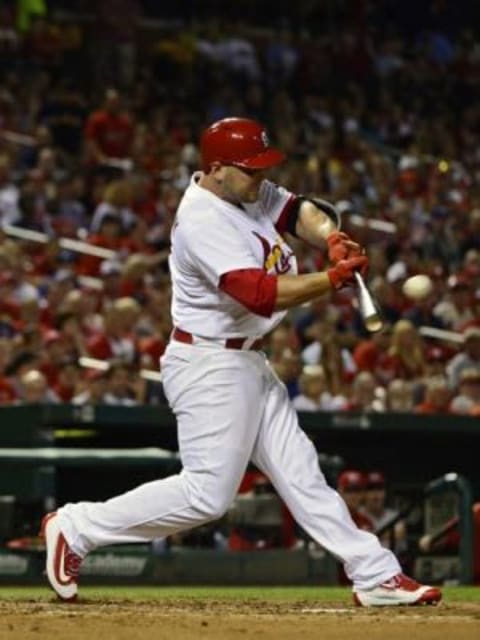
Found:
85,88 -> 134,164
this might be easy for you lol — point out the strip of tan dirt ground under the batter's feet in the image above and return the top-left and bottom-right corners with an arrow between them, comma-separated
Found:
0,599 -> 480,640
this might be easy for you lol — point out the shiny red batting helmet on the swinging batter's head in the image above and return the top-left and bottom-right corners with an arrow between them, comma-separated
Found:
200,118 -> 285,171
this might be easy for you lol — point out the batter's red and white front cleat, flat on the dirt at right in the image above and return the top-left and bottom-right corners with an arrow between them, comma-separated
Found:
353,573 -> 442,607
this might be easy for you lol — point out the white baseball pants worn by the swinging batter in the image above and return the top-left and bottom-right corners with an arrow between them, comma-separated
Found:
58,342 -> 401,589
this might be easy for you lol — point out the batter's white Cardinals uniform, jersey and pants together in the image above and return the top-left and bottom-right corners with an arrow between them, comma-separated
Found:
58,174 -> 400,589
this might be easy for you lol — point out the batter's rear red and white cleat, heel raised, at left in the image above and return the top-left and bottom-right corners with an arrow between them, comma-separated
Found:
40,512 -> 82,602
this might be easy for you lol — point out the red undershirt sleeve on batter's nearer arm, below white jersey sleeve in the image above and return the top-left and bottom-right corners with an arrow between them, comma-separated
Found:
219,269 -> 277,318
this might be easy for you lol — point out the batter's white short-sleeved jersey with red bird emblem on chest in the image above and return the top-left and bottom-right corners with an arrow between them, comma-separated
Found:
169,173 -> 297,338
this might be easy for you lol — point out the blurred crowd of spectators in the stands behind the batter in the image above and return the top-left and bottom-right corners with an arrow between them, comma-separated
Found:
0,0 -> 480,415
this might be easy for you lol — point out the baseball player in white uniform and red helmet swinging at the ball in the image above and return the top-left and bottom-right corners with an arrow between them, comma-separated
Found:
42,118 -> 441,606
